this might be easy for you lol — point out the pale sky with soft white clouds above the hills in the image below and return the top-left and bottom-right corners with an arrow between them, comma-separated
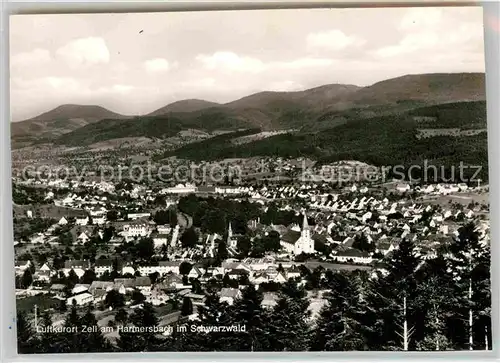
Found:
10,7 -> 485,121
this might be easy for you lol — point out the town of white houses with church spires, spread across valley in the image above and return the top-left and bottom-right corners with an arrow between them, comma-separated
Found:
13,158 -> 490,352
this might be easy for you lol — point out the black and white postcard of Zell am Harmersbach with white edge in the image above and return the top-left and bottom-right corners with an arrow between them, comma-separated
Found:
8,6 -> 493,354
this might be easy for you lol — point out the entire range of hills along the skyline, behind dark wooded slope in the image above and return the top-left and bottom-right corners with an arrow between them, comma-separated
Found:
12,73 -> 485,146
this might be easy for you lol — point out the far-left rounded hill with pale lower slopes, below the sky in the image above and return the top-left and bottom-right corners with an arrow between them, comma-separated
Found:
11,105 -> 129,142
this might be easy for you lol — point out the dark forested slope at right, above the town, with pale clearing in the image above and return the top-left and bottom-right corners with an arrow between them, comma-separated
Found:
163,102 -> 488,182
